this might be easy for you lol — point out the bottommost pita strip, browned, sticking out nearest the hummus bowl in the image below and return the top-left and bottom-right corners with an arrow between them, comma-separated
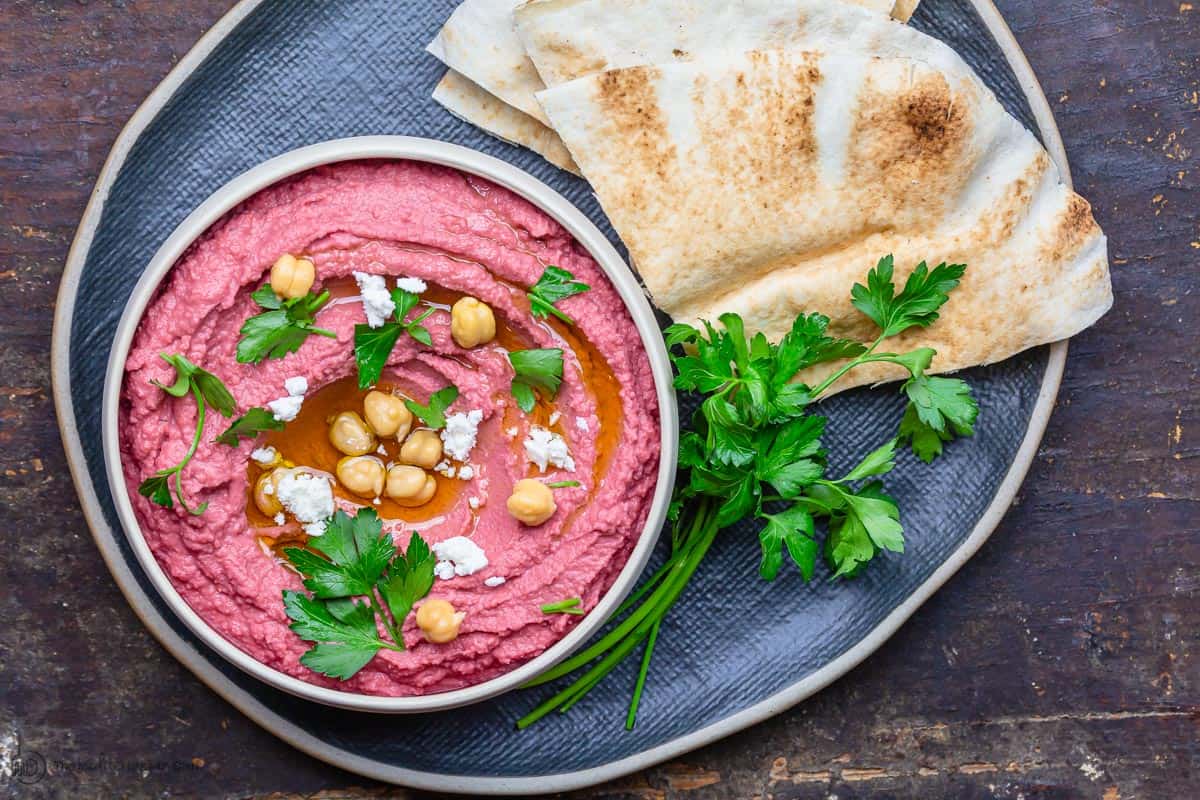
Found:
433,70 -> 580,175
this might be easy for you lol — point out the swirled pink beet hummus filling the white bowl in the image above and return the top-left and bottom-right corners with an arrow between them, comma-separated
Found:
120,161 -> 660,696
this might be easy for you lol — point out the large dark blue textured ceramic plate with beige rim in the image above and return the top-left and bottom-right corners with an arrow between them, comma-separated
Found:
53,0 -> 1067,795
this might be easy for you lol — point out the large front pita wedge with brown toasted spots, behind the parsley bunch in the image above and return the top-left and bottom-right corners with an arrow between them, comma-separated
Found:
539,52 -> 1112,389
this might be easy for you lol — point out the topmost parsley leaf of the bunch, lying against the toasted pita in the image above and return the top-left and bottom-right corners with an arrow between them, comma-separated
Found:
851,255 -> 967,337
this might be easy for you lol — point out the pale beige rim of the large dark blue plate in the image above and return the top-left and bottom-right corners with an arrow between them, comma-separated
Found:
50,0 -> 1072,795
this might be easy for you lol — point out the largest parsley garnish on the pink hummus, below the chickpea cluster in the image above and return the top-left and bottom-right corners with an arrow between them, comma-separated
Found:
283,509 -> 436,680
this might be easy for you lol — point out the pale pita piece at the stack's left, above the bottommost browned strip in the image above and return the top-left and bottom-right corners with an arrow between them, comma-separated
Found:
426,0 -> 916,130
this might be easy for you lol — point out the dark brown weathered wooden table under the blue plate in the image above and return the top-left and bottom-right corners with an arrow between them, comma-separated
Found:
0,0 -> 1200,800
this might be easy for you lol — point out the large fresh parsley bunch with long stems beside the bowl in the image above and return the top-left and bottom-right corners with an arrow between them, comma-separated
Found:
517,257 -> 978,728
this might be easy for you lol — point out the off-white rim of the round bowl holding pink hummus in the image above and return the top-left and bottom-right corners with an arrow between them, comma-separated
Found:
103,136 -> 679,714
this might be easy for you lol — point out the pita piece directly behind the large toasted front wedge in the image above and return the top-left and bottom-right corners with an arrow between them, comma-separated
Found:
514,0 -> 926,86
